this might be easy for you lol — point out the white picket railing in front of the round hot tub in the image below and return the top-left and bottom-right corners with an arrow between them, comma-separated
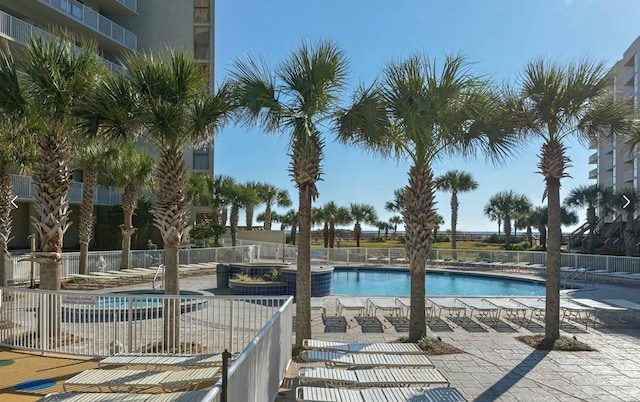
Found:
0,288 -> 291,356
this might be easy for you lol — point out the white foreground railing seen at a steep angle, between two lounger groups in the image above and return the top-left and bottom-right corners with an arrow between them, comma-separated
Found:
202,298 -> 293,402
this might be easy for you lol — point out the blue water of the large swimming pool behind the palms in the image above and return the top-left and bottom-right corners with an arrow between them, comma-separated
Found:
331,267 -> 545,296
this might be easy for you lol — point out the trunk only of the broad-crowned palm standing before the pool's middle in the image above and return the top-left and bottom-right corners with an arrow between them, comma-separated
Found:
402,162 -> 436,342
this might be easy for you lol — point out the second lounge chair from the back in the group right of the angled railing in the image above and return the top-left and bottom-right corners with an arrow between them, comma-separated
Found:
300,350 -> 434,368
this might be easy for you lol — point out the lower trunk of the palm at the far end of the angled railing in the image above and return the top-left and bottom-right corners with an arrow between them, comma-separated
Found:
296,186 -> 312,347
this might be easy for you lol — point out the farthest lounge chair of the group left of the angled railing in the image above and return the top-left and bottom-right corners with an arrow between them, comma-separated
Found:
98,353 -> 222,370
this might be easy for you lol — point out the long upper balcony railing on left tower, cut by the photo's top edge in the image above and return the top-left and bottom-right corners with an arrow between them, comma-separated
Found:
39,0 -> 138,50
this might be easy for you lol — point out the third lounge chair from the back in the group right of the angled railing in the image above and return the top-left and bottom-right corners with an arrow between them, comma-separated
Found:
298,367 -> 449,388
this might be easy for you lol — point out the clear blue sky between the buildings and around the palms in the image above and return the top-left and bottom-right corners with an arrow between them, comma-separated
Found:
214,0 -> 640,231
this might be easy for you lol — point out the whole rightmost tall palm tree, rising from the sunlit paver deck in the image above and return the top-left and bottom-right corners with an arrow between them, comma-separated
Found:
507,59 -> 633,342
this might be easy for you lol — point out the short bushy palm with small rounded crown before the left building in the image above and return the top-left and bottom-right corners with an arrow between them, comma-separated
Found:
102,141 -> 156,269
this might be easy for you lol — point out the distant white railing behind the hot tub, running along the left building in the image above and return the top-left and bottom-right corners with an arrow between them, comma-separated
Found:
7,245 -> 260,285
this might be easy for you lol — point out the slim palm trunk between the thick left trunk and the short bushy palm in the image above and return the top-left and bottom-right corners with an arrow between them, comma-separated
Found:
78,162 -> 98,275
